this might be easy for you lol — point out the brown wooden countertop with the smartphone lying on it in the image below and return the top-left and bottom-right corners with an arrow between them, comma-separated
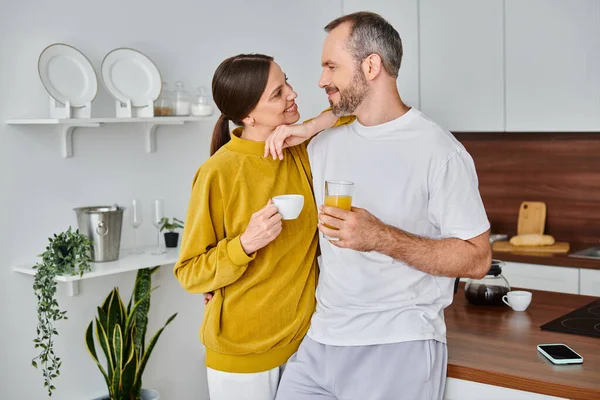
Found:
445,283 -> 600,400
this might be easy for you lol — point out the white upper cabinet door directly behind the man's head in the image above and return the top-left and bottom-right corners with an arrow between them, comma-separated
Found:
342,0 -> 420,108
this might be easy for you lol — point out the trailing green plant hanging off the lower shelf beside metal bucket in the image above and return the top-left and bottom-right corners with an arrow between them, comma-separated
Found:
31,226 -> 92,396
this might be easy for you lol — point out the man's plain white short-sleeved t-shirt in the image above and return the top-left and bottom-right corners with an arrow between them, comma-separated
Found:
308,108 -> 490,346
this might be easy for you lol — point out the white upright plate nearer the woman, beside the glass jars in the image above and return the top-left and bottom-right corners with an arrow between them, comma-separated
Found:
101,48 -> 162,107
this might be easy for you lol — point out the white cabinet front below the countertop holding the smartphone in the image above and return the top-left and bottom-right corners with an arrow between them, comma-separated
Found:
444,378 -> 566,400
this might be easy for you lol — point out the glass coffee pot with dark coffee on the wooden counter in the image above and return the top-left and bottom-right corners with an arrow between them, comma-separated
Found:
465,260 -> 510,306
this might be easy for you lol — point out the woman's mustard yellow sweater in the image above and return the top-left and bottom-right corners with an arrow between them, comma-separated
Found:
174,129 -> 318,372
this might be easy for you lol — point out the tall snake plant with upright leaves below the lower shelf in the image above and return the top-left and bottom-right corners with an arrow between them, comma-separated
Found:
85,267 -> 177,400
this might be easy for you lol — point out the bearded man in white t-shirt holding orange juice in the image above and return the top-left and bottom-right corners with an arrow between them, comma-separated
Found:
277,12 -> 491,400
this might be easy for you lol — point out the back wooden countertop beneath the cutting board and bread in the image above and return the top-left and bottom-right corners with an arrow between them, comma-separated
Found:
492,243 -> 600,270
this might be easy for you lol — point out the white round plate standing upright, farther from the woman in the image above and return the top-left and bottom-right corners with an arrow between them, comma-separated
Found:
38,43 -> 98,107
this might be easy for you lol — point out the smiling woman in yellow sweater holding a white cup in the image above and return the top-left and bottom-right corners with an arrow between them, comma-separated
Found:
174,54 -> 352,400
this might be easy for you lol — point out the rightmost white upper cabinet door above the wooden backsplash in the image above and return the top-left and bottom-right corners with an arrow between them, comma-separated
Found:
506,0 -> 600,131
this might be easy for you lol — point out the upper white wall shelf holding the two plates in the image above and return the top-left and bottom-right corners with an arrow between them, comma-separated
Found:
6,116 -> 213,158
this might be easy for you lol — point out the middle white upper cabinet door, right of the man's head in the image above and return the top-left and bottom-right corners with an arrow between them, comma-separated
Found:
419,0 -> 504,131
